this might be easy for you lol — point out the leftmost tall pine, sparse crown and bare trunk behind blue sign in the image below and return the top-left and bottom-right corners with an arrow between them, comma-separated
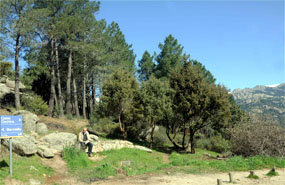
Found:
0,0 -> 36,110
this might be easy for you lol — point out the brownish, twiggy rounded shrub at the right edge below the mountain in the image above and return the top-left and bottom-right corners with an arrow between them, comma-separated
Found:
231,119 -> 285,156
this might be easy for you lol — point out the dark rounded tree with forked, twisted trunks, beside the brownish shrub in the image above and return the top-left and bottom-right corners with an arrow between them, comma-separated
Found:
166,63 -> 230,153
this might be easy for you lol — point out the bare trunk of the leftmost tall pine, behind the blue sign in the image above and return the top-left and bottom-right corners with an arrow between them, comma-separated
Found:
15,34 -> 21,110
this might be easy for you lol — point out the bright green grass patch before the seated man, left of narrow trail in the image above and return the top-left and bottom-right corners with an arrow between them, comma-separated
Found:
63,148 -> 168,182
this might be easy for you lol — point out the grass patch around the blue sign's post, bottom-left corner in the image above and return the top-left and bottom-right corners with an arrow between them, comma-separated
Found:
0,155 -> 53,184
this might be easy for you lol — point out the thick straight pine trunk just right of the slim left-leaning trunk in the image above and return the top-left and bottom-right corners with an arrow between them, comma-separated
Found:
66,50 -> 72,114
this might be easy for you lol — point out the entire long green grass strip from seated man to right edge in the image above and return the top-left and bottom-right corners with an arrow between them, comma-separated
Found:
64,148 -> 285,182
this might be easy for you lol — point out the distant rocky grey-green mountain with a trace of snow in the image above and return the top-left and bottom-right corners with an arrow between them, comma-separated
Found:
231,83 -> 285,126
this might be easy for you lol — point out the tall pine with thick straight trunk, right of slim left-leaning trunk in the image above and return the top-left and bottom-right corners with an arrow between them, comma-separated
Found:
56,0 -> 99,114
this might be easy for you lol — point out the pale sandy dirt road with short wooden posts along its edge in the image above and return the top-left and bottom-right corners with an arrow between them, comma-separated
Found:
93,169 -> 285,185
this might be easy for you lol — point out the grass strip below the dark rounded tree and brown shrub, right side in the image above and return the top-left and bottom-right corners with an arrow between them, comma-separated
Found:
170,150 -> 285,173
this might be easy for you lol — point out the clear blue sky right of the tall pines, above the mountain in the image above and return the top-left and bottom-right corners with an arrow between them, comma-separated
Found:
97,0 -> 285,90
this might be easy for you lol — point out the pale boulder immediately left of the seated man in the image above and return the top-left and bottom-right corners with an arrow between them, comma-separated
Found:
40,132 -> 77,152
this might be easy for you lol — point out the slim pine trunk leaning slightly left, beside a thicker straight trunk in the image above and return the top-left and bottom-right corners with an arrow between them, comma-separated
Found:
55,39 -> 64,117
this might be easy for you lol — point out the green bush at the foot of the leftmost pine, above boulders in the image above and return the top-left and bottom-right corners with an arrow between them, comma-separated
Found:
21,93 -> 48,115
